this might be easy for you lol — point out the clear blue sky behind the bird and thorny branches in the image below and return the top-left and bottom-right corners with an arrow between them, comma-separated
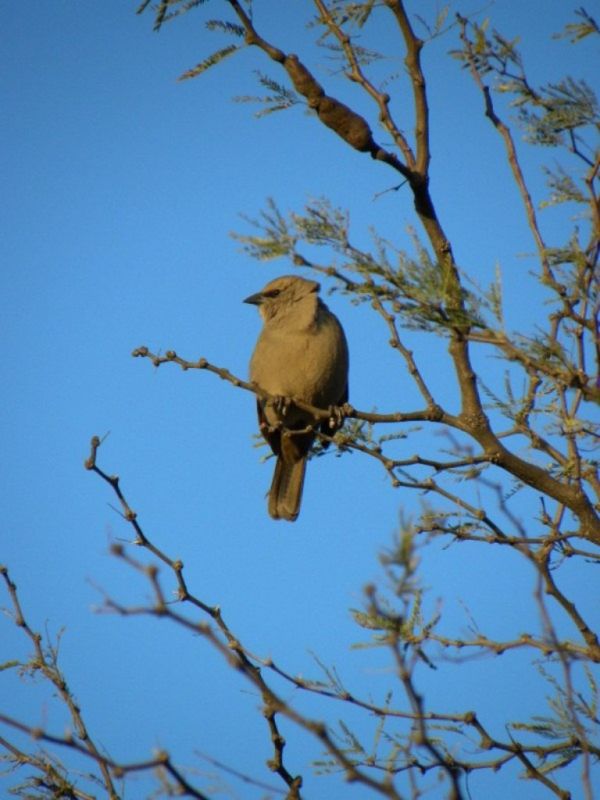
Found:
0,0 -> 598,800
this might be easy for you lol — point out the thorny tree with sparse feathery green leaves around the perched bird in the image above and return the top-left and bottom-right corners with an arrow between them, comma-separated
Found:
0,0 -> 600,798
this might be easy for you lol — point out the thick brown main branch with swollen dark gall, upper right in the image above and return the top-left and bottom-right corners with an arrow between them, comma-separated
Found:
143,0 -> 600,543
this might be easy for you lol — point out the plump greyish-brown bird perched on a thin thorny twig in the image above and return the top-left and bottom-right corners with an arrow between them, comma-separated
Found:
244,275 -> 349,522
